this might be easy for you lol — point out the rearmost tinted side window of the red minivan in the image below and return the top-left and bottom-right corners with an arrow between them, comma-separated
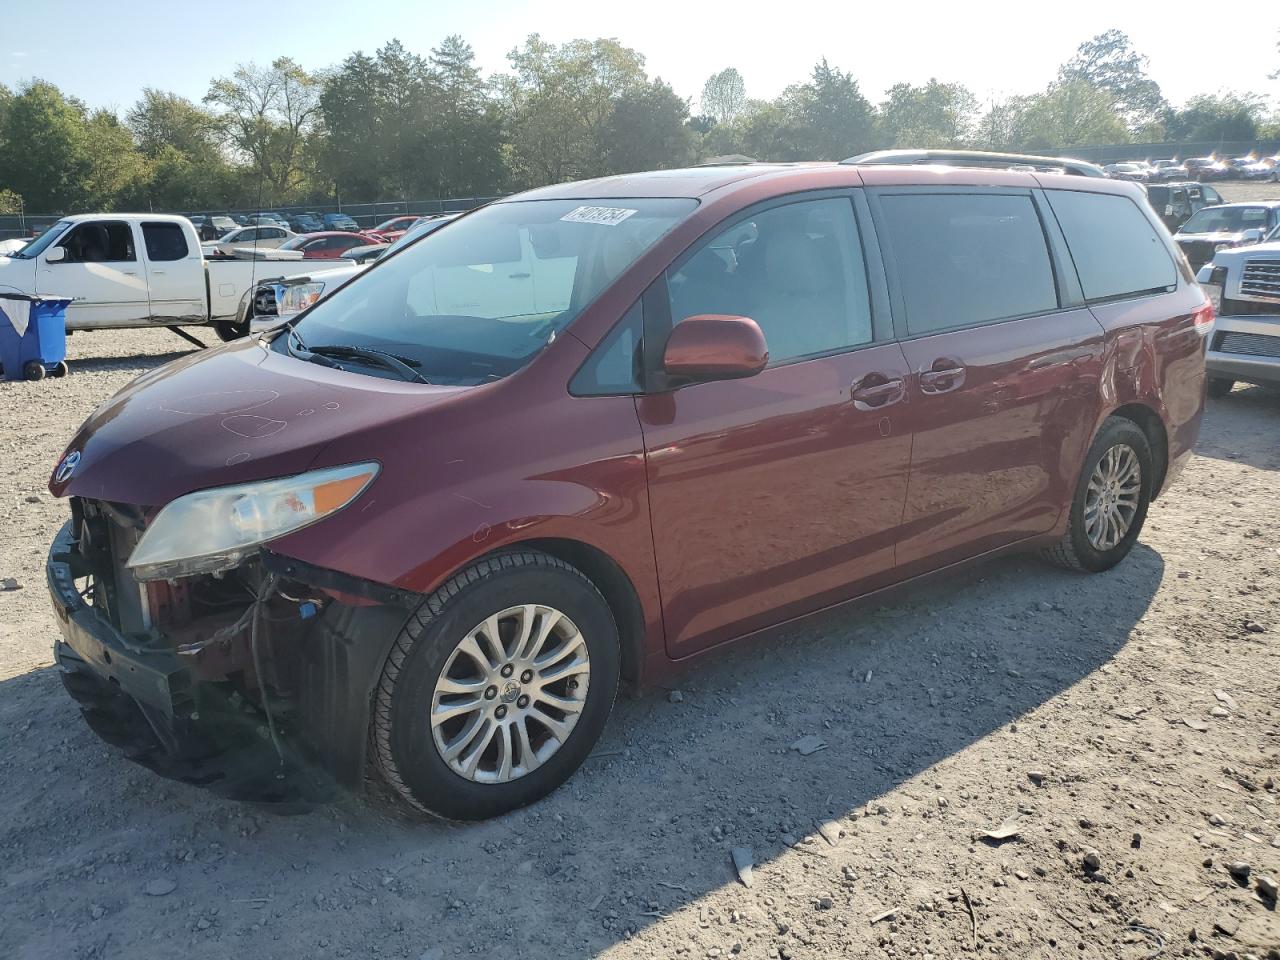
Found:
1047,191 -> 1178,300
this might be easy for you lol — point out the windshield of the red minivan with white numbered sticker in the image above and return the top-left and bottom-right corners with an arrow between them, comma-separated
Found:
273,198 -> 698,385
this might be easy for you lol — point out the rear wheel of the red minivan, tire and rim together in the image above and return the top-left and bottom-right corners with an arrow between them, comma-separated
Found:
1046,417 -> 1153,573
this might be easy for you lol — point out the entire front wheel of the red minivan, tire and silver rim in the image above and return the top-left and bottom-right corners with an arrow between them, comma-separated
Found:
370,550 -> 620,820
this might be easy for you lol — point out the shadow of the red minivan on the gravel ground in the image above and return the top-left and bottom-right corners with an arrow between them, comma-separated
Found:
0,545 -> 1165,959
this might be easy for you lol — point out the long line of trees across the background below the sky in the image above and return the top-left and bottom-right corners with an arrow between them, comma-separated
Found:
0,29 -> 1280,212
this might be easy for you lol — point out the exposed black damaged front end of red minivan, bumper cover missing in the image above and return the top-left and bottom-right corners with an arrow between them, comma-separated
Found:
46,519 -> 415,803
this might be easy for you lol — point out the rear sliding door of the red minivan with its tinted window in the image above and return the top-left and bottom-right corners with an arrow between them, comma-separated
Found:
874,188 -> 1102,576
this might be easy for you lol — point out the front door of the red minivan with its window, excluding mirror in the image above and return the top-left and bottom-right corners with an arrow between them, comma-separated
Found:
637,195 -> 911,657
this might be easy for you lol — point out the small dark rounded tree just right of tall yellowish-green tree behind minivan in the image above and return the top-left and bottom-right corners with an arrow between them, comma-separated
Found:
604,79 -> 694,173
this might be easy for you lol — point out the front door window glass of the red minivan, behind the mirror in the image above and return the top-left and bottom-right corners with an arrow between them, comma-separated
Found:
667,197 -> 872,364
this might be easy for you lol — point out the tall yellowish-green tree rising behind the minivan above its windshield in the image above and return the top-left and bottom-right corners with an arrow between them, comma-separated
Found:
497,33 -> 648,186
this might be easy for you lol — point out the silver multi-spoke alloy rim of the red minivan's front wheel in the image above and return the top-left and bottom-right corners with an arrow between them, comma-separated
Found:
431,603 -> 591,783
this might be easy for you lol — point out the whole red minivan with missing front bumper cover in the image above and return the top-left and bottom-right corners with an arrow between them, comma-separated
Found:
49,161 -> 1212,819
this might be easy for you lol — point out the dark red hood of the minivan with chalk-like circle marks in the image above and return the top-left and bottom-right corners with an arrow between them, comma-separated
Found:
49,338 -> 470,507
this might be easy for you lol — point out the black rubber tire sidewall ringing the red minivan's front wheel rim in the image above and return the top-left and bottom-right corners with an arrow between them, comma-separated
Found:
389,566 -> 620,820
